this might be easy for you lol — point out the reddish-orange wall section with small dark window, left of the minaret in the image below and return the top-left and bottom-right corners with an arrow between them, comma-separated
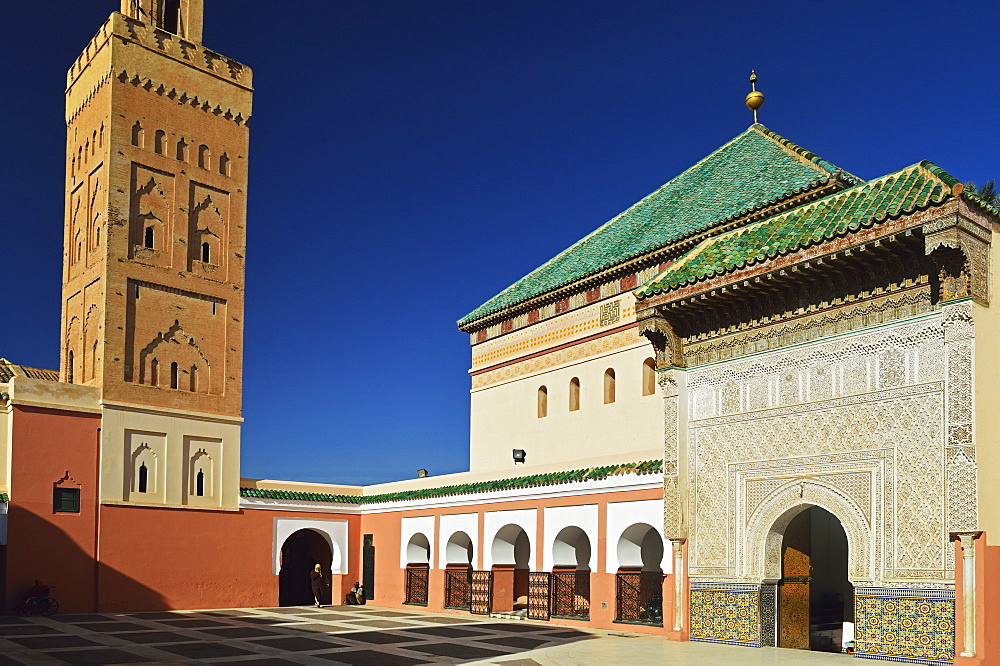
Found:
5,405 -> 101,612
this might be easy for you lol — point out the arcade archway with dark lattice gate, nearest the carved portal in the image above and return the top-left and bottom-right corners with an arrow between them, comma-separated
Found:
615,523 -> 663,626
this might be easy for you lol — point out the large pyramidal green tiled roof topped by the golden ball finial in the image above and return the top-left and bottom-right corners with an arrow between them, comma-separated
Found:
458,125 -> 862,327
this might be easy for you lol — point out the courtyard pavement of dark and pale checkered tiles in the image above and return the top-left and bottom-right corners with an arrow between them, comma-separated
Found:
0,606 -> 849,666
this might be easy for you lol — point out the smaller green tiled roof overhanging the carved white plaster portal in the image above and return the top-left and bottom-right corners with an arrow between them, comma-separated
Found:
633,162 -> 958,299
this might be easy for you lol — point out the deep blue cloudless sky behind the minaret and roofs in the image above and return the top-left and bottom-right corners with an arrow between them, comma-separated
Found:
0,0 -> 1000,483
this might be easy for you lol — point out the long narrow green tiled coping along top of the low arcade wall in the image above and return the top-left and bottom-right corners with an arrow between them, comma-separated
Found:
240,460 -> 663,504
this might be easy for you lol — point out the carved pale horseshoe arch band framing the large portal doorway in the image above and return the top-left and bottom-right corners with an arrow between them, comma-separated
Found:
740,480 -> 876,583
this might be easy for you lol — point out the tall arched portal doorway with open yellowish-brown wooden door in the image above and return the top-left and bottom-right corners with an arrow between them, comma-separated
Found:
778,506 -> 854,652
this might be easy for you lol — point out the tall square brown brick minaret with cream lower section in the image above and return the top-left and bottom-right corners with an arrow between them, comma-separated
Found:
61,0 -> 252,504
